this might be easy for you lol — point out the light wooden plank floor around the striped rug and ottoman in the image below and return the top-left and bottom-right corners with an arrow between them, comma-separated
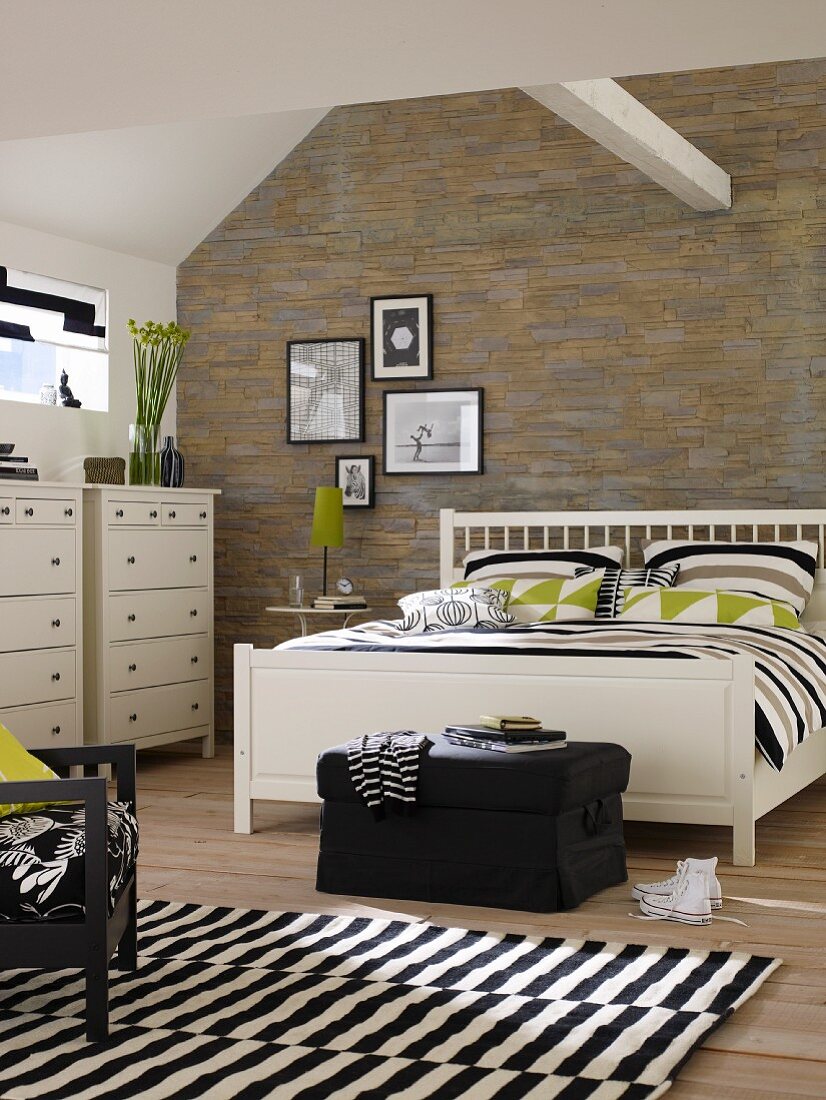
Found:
139,747 -> 826,1100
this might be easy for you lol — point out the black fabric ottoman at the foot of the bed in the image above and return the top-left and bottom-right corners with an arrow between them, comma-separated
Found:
316,734 -> 631,913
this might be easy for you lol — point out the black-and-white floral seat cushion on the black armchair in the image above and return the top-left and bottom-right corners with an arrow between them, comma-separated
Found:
0,802 -> 137,922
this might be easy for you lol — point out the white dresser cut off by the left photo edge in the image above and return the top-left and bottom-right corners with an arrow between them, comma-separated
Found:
0,481 -> 82,748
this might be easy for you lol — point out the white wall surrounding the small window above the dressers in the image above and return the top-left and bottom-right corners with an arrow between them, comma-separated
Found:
0,222 -> 176,482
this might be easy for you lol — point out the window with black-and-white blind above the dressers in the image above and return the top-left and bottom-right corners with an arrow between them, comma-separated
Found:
0,267 -> 109,411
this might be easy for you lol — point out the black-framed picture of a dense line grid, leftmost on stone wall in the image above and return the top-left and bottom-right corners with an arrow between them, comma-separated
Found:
287,337 -> 364,443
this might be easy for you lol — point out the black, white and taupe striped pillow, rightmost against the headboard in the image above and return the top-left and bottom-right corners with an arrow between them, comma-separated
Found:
641,539 -> 817,614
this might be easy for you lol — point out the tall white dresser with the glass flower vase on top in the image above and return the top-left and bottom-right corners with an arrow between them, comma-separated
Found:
84,485 -> 217,757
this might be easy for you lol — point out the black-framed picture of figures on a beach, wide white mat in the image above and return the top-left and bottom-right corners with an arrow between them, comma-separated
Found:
384,389 -> 484,474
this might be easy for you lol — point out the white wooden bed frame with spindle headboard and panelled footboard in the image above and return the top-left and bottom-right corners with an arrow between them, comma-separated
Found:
234,509 -> 826,866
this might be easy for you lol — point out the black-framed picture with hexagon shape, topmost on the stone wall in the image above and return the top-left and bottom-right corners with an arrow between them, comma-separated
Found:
370,294 -> 433,382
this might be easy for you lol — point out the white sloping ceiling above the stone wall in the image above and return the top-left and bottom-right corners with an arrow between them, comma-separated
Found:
0,0 -> 826,263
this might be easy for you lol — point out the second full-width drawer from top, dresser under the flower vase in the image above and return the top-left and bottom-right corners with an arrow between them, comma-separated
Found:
109,589 -> 210,641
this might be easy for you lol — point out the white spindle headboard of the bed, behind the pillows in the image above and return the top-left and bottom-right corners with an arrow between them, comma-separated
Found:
439,508 -> 826,628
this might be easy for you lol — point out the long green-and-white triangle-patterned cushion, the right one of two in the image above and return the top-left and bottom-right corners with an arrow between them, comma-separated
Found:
619,586 -> 801,630
